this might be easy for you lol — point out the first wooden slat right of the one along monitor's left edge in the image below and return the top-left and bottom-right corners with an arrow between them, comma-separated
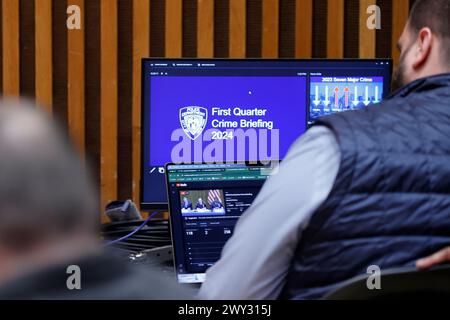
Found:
165,0 -> 183,58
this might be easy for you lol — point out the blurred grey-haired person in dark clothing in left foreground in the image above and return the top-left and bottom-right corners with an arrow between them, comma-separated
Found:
0,100 -> 190,299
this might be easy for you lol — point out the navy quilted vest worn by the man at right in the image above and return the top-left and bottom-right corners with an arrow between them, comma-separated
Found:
280,74 -> 450,299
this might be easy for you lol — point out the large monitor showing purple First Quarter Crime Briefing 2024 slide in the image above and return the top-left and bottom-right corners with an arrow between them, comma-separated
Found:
141,59 -> 392,210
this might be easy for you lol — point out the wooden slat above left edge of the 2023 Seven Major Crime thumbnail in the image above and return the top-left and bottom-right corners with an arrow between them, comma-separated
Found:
295,0 -> 313,58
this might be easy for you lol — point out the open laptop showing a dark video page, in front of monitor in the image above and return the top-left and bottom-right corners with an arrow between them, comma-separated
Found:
166,163 -> 275,284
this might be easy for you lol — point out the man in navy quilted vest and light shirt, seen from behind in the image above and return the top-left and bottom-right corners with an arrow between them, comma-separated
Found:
200,0 -> 450,299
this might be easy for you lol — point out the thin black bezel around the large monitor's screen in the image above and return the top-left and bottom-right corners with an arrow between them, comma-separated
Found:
139,57 -> 393,212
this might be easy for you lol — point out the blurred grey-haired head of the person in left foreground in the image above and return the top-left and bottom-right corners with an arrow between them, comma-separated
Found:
0,101 -> 98,278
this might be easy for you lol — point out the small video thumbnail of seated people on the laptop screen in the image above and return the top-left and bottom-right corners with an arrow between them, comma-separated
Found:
180,189 -> 225,216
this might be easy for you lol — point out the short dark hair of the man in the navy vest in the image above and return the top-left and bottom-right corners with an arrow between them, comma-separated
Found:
409,0 -> 450,64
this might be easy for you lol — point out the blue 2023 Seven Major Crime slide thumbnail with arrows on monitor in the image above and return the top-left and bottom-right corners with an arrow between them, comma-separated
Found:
309,77 -> 383,122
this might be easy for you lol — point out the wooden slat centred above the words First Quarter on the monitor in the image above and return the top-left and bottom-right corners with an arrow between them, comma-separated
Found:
229,0 -> 246,58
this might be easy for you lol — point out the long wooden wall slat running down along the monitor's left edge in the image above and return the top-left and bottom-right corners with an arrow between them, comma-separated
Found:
132,0 -> 150,203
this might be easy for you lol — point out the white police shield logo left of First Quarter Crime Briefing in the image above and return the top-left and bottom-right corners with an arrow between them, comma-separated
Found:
180,107 -> 208,140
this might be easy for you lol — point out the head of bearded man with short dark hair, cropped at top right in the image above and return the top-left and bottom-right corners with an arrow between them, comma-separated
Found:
393,0 -> 450,89
